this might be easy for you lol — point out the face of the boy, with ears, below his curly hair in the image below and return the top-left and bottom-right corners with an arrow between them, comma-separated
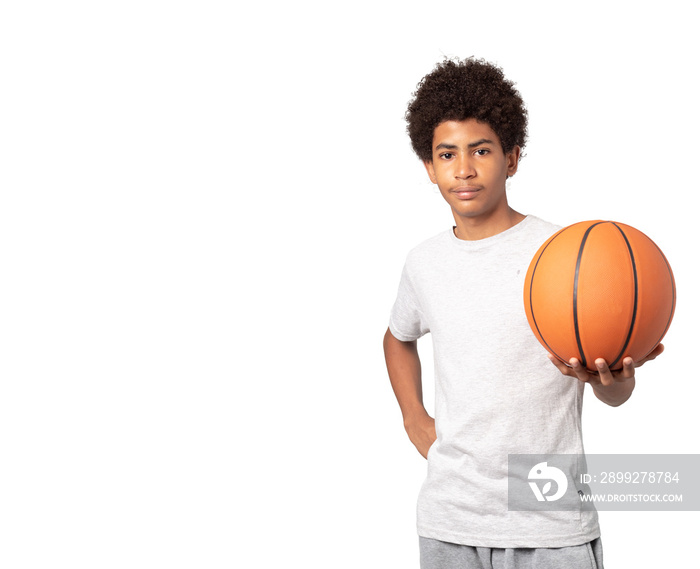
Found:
425,119 -> 520,232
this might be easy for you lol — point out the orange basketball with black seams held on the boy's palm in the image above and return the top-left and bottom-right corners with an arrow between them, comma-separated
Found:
523,221 -> 676,370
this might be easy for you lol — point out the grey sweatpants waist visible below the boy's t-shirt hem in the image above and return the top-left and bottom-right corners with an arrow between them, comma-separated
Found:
418,536 -> 604,569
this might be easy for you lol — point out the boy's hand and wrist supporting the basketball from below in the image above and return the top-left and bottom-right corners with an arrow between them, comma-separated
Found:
549,344 -> 664,407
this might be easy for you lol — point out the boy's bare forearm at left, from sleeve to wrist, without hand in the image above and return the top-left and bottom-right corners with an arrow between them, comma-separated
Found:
384,329 -> 427,424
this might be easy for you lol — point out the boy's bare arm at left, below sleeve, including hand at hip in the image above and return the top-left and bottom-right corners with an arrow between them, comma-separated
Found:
384,328 -> 437,458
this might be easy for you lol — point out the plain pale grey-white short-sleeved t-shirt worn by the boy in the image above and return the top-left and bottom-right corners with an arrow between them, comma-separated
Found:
389,216 -> 600,548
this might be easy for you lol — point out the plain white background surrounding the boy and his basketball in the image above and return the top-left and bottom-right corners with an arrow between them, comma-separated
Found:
0,1 -> 700,569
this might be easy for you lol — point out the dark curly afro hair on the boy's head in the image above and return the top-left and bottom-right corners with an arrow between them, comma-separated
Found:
405,57 -> 527,162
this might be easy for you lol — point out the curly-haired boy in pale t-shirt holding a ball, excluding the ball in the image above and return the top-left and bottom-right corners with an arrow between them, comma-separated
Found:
384,58 -> 663,569
